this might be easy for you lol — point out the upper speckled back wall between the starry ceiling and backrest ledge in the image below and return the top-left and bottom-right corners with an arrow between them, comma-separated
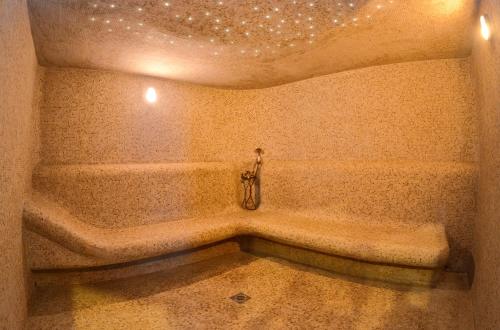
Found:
41,59 -> 477,164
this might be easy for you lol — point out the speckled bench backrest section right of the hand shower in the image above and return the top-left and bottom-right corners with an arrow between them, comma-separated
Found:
262,161 -> 477,271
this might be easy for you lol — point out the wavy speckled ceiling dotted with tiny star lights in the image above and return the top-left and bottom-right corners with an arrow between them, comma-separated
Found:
29,0 -> 475,88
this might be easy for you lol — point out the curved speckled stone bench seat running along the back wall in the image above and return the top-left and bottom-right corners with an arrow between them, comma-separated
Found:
24,194 -> 449,268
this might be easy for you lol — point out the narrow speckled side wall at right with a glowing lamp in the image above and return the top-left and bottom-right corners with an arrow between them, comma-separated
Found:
472,0 -> 500,329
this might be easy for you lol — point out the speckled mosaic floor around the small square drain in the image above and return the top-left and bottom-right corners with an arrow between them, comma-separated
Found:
28,253 -> 473,330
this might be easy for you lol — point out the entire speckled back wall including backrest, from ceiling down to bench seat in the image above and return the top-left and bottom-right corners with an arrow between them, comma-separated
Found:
38,59 -> 477,270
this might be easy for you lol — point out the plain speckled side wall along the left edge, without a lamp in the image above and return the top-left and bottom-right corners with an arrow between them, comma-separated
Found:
0,0 -> 38,330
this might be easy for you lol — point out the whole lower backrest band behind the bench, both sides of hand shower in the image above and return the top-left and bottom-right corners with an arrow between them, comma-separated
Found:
31,160 -> 477,271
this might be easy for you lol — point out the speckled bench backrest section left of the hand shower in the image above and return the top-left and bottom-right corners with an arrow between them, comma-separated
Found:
33,163 -> 241,228
